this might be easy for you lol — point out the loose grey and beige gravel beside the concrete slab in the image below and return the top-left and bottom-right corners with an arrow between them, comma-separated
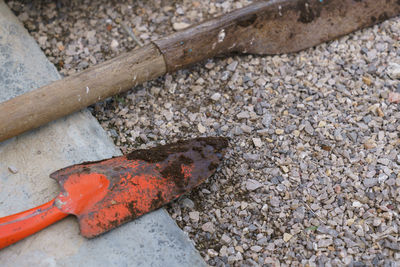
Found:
7,0 -> 400,266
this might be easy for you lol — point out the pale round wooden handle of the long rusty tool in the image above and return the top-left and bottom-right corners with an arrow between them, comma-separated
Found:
0,44 -> 166,142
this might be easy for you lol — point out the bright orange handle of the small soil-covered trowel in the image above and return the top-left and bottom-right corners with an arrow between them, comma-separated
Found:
0,199 -> 68,249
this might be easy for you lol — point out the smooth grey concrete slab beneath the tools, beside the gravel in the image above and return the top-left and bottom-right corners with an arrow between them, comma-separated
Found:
0,0 -> 206,267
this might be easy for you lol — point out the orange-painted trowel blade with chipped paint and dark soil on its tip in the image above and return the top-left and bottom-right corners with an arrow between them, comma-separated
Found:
50,137 -> 228,238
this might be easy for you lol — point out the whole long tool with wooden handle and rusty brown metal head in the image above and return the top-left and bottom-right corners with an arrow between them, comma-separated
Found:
0,0 -> 400,142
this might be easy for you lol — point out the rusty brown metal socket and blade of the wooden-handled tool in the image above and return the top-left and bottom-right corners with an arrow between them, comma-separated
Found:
154,0 -> 400,72
